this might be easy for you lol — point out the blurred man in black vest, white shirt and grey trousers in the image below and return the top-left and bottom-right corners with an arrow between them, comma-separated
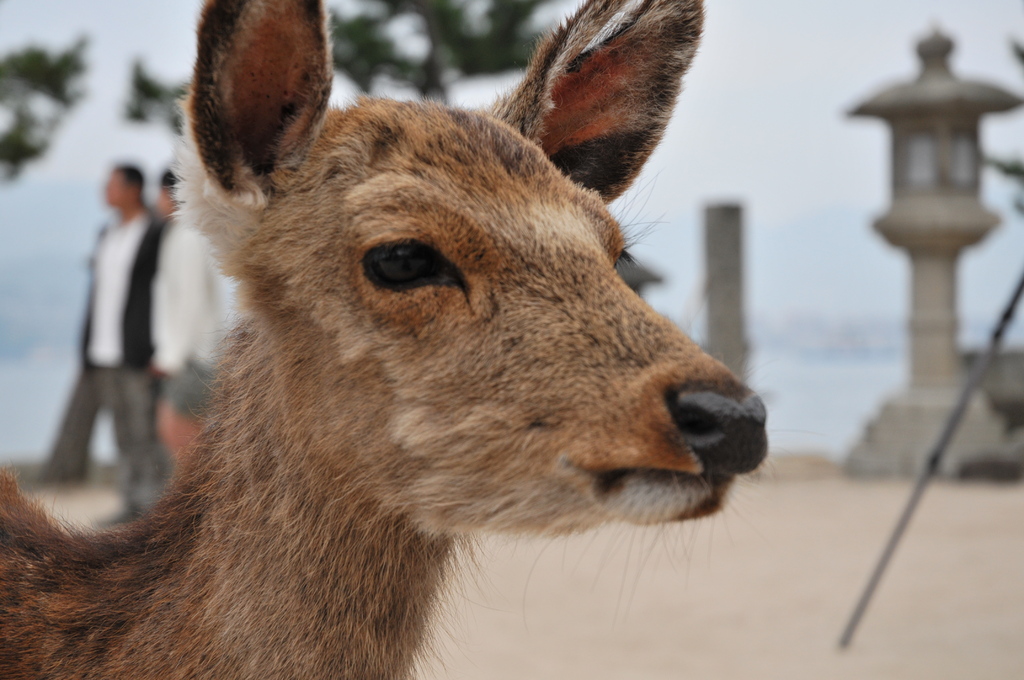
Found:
51,165 -> 170,522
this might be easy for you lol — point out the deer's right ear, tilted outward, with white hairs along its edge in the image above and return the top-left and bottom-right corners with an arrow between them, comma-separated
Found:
493,0 -> 703,201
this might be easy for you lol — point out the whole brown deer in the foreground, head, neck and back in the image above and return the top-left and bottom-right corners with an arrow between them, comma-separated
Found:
0,0 -> 767,680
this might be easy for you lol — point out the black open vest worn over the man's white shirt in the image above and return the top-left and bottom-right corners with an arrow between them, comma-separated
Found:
82,215 -> 164,369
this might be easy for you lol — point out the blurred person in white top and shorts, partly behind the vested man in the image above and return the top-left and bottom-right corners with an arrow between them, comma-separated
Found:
153,170 -> 224,460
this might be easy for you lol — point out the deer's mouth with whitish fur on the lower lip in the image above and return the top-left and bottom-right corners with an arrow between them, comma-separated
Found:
588,467 -> 733,524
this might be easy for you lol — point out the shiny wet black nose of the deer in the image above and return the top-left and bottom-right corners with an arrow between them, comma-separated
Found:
668,390 -> 768,474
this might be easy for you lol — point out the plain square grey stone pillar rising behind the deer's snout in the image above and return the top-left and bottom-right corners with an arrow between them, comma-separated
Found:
705,204 -> 749,380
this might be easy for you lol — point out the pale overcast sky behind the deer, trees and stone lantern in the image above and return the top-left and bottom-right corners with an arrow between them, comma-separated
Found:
0,0 -> 1024,333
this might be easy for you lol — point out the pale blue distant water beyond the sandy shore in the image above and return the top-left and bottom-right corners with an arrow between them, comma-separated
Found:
0,350 -> 903,464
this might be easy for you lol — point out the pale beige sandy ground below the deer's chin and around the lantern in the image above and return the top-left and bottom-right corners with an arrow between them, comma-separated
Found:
22,460 -> 1024,680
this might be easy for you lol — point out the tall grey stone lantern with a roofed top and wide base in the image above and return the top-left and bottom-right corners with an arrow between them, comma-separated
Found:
847,30 -> 1021,475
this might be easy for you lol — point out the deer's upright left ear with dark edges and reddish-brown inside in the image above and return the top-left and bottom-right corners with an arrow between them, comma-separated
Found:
185,0 -> 333,195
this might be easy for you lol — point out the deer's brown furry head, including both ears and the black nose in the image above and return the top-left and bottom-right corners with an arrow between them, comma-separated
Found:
179,0 -> 766,533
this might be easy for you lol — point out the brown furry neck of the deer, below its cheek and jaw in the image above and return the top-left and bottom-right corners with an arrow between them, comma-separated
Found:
183,325 -> 455,680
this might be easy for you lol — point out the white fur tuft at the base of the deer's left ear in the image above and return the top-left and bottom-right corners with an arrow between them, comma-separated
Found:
174,133 -> 267,275
